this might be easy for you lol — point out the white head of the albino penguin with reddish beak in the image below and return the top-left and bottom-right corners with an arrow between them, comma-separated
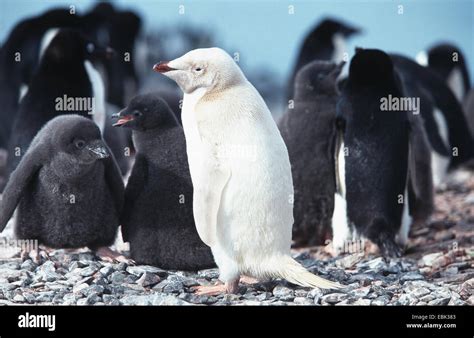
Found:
153,48 -> 246,94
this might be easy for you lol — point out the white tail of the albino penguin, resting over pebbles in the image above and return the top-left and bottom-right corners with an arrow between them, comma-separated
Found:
273,256 -> 343,289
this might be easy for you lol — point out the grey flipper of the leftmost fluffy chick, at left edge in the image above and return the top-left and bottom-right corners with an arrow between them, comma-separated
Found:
0,144 -> 42,232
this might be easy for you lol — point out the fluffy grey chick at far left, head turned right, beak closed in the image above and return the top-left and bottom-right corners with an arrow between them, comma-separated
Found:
0,115 -> 124,250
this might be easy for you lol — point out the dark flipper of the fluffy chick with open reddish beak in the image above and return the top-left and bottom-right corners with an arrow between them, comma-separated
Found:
120,154 -> 148,242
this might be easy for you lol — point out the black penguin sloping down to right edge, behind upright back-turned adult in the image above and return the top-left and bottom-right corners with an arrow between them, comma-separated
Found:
390,54 -> 474,170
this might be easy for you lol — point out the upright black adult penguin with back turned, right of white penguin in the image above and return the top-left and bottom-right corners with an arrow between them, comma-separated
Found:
332,49 -> 409,256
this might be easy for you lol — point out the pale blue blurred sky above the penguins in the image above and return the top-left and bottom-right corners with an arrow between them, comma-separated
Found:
0,0 -> 474,79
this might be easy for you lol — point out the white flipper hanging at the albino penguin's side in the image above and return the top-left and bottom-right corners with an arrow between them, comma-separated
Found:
193,157 -> 231,247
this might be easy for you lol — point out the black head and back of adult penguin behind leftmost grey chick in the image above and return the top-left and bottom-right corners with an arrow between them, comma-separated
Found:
8,29 -> 109,176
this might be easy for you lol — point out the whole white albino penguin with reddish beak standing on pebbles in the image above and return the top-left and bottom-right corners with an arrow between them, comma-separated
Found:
154,48 -> 340,295
